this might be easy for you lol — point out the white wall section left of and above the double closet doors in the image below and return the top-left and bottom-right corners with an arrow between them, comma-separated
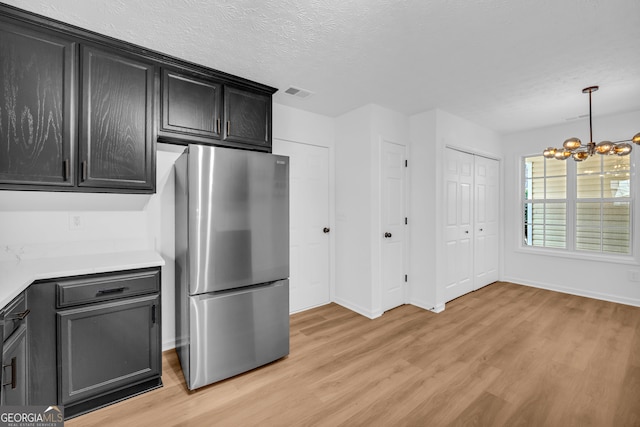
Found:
409,110 -> 502,311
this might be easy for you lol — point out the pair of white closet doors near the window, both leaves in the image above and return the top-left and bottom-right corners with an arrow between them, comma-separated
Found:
444,148 -> 500,301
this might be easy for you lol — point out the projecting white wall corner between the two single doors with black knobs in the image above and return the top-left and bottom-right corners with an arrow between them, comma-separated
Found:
334,104 -> 409,318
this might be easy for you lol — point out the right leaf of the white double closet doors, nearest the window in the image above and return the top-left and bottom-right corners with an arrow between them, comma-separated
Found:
473,156 -> 500,290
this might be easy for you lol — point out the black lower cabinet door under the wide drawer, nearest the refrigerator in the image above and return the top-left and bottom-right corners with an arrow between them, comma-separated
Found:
57,295 -> 161,405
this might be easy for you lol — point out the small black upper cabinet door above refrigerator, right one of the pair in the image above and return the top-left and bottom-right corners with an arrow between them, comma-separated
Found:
223,86 -> 271,148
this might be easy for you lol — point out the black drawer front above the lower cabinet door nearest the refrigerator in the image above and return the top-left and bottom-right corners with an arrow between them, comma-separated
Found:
56,269 -> 160,308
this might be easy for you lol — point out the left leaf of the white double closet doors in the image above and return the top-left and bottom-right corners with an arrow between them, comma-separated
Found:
444,149 -> 474,301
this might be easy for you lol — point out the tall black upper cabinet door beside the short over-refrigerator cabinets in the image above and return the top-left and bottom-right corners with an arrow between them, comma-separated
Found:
79,46 -> 155,191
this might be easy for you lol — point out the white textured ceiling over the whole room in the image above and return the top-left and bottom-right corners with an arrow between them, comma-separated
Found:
5,0 -> 640,132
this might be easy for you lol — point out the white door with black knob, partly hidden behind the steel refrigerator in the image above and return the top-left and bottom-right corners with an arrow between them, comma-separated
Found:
273,139 -> 331,313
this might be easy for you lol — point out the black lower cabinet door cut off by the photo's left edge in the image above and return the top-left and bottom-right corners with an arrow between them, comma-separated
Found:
1,325 -> 27,406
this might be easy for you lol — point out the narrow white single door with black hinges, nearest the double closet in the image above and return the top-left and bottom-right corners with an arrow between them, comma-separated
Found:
380,141 -> 405,311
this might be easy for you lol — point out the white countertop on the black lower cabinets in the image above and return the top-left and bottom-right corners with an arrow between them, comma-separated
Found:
0,250 -> 164,308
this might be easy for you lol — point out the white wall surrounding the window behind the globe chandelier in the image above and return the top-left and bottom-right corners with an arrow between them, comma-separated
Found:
503,111 -> 640,306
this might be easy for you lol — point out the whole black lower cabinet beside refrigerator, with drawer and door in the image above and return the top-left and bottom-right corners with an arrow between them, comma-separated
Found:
27,267 -> 162,418
